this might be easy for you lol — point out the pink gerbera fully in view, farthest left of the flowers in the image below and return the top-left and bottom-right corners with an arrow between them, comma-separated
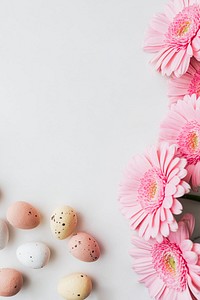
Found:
120,142 -> 190,241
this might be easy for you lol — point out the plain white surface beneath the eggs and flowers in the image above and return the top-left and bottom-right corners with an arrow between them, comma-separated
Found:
0,0 -> 185,300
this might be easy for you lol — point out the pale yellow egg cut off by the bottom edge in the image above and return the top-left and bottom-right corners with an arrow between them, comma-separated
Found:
58,273 -> 92,300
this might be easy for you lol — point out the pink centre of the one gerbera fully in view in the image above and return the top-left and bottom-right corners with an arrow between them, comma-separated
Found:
138,168 -> 166,212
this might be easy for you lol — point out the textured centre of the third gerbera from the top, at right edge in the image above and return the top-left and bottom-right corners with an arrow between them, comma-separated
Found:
177,121 -> 200,165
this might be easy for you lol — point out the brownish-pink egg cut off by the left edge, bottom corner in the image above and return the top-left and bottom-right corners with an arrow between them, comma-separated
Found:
0,268 -> 23,297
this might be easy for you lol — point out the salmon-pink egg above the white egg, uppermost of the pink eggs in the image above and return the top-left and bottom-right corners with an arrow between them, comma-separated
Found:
7,201 -> 40,229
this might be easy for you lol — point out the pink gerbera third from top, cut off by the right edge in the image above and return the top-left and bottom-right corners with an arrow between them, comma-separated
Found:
160,95 -> 200,189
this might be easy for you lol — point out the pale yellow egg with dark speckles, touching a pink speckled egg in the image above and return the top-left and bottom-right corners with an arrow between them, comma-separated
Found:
50,205 -> 77,240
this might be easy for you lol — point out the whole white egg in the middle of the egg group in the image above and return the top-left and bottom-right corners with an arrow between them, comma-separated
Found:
16,242 -> 50,269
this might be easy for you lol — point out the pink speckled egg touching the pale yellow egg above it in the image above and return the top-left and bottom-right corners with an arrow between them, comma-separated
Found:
68,232 -> 100,262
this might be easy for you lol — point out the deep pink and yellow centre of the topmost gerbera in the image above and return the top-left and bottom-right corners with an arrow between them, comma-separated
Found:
165,4 -> 200,49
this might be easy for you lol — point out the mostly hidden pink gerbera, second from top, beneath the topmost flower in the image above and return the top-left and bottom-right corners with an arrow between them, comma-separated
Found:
168,58 -> 200,104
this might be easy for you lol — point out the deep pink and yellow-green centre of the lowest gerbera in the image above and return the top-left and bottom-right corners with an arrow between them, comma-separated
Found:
151,238 -> 188,292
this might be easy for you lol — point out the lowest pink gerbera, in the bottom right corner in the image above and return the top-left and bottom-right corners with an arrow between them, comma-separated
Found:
131,214 -> 200,300
